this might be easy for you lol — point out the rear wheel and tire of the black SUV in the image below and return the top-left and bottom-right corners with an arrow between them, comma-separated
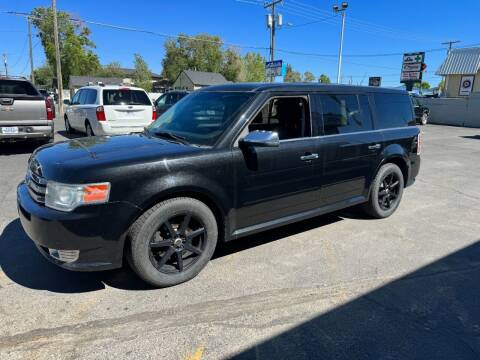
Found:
364,163 -> 404,219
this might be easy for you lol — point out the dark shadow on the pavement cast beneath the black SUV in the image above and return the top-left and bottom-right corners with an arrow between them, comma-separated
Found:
0,215 -> 341,293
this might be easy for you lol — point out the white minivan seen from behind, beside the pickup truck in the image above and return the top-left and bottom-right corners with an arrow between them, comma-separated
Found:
64,85 -> 156,136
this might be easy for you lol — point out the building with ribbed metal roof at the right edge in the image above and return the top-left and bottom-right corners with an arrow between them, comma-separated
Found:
436,47 -> 480,97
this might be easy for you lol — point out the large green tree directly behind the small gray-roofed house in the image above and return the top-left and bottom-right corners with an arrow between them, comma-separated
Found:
162,34 -> 224,81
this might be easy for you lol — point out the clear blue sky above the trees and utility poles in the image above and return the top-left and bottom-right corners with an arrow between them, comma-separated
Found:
0,0 -> 480,86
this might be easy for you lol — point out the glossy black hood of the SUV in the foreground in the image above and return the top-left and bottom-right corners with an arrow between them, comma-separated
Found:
32,134 -> 202,181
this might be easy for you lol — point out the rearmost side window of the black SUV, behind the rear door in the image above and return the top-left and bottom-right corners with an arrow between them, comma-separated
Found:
374,93 -> 415,129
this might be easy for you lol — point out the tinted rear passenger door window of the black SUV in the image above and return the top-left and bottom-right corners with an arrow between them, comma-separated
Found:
316,94 -> 373,135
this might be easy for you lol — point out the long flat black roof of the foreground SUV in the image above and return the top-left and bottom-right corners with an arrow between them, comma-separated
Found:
197,83 -> 407,94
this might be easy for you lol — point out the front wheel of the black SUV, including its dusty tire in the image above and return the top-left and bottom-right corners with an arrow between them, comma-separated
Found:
126,197 -> 218,287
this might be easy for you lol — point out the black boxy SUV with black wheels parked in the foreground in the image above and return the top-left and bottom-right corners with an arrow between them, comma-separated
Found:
18,84 -> 420,286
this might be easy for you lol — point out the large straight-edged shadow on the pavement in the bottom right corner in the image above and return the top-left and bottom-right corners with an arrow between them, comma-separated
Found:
232,242 -> 480,360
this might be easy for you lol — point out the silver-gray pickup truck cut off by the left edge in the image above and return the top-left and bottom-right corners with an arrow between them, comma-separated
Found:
0,77 -> 55,143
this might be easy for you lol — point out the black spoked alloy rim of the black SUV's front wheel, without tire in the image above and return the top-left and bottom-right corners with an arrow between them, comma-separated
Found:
149,212 -> 207,274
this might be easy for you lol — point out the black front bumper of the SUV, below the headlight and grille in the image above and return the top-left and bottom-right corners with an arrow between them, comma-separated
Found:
17,183 -> 139,271
